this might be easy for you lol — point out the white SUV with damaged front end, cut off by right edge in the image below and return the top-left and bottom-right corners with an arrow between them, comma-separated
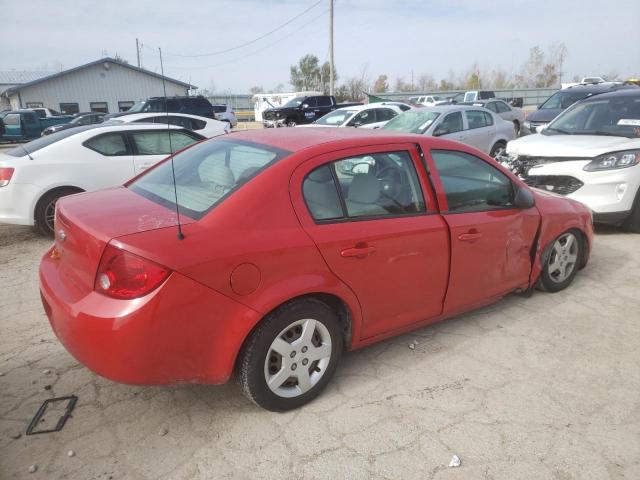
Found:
499,88 -> 640,233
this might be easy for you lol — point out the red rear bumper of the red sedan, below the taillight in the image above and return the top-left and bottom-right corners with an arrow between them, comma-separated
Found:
40,248 -> 261,385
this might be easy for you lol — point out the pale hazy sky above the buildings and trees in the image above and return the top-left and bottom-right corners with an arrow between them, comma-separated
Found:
0,0 -> 640,93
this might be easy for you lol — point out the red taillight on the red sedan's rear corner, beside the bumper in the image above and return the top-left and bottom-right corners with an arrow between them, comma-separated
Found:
94,245 -> 171,299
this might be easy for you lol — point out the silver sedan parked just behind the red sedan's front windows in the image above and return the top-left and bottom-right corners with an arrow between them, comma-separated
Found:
384,105 -> 516,158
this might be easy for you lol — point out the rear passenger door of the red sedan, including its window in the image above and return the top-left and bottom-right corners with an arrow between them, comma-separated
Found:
290,144 -> 449,339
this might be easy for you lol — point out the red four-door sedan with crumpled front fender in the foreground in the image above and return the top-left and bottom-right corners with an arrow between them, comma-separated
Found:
40,128 -> 593,410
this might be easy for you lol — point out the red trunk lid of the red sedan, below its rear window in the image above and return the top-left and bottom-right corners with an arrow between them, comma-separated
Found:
55,187 -> 194,295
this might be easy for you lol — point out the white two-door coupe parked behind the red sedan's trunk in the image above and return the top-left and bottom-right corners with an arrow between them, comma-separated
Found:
0,123 -> 205,235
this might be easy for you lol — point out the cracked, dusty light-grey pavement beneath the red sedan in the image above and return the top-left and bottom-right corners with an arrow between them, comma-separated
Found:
0,226 -> 640,480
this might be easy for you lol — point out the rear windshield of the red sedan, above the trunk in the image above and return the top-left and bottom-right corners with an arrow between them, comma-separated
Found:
128,139 -> 290,220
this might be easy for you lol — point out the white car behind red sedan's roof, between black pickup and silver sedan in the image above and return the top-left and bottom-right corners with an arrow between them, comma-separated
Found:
297,103 -> 402,128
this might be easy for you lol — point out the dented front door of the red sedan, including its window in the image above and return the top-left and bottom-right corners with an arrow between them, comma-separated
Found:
427,150 -> 540,314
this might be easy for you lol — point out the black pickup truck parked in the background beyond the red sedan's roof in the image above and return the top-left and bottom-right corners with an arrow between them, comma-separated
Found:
262,95 -> 362,128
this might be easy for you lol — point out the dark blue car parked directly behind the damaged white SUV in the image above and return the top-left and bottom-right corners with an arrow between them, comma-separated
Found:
520,83 -> 638,135
